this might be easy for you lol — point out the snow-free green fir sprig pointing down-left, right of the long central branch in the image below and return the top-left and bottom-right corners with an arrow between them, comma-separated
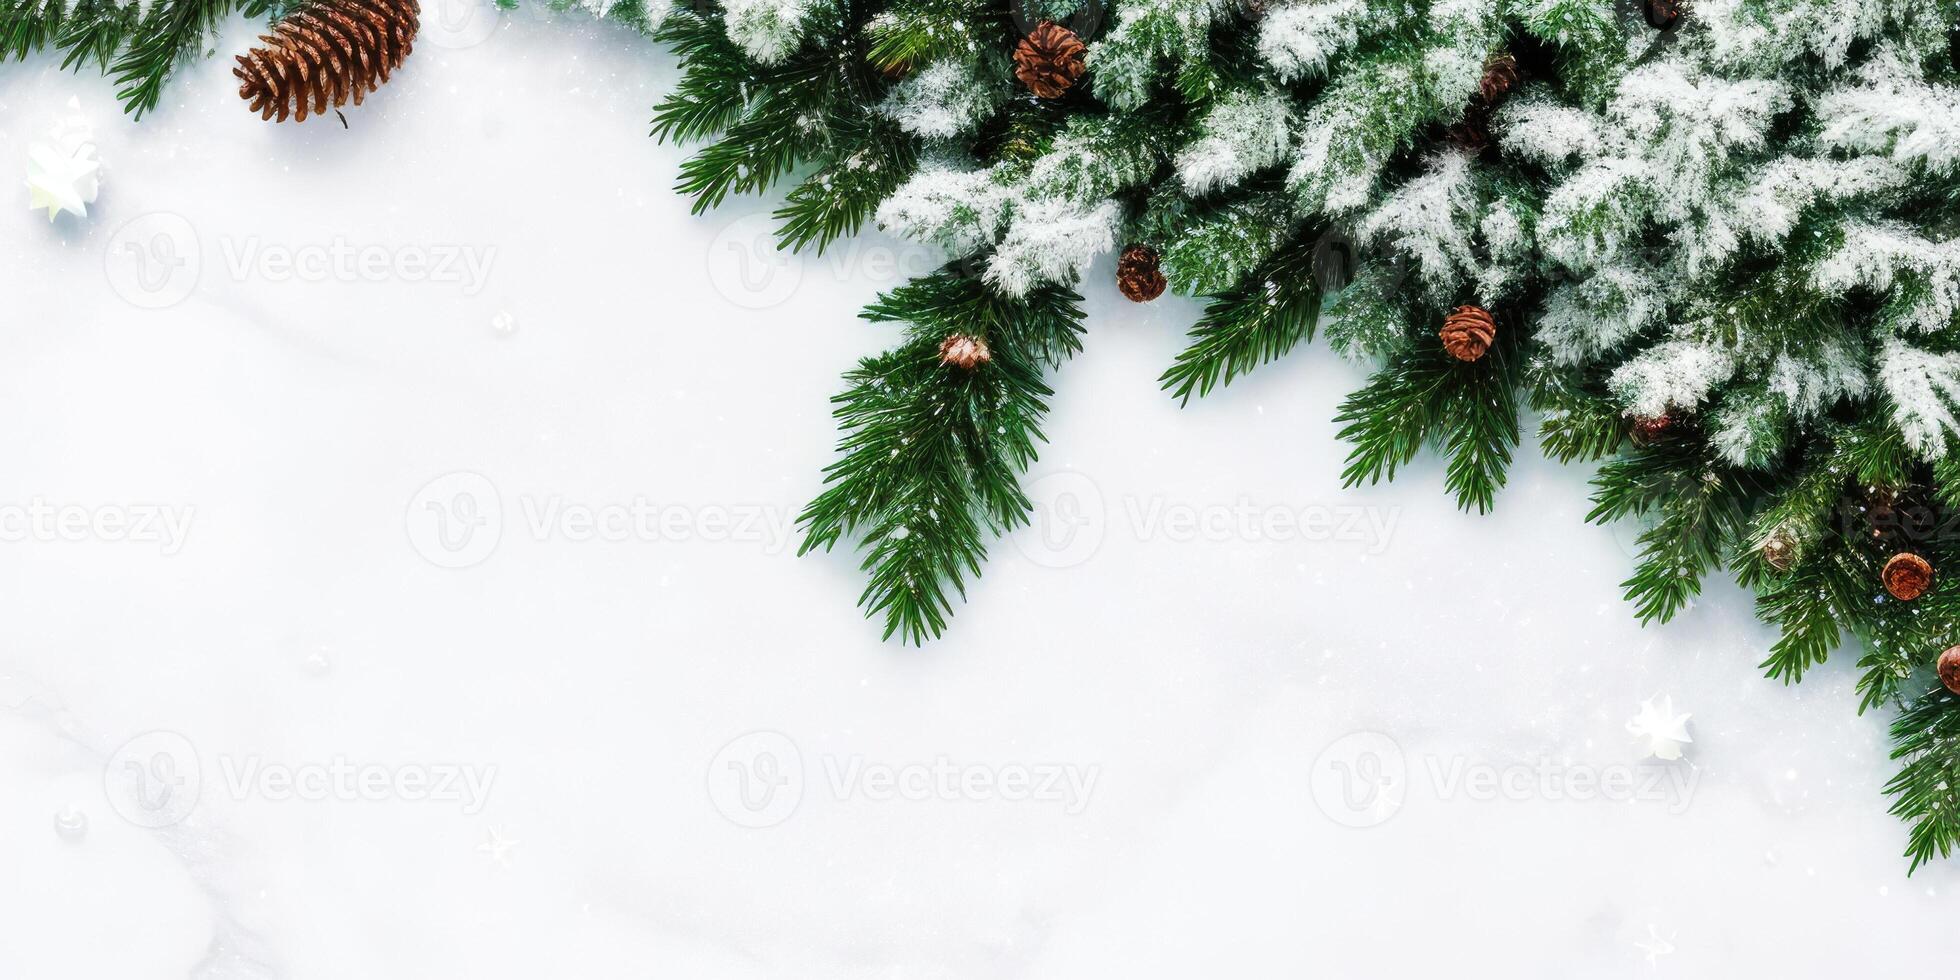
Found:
1156,239 -> 1321,404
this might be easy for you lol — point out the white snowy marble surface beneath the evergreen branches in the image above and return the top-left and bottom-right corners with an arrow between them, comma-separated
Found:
0,8 -> 1960,980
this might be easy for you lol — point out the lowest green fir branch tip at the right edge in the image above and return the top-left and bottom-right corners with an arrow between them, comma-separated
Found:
1886,690 -> 1960,874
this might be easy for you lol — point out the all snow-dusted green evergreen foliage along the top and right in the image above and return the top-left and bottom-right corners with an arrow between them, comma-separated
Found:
11,0 -> 1960,868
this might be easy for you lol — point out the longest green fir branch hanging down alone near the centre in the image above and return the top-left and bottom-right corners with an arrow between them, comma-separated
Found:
798,267 -> 1082,643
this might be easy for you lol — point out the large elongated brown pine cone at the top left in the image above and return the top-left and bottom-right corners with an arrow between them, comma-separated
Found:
231,0 -> 419,122
